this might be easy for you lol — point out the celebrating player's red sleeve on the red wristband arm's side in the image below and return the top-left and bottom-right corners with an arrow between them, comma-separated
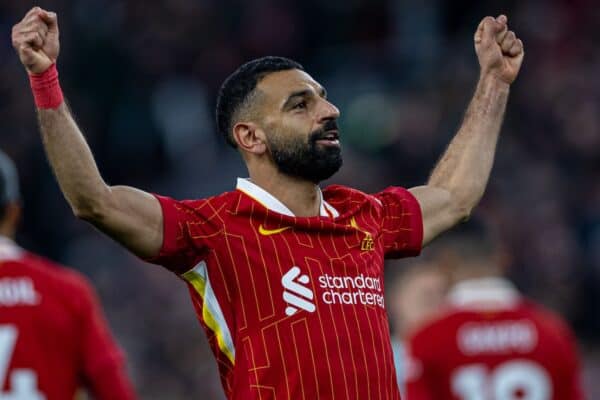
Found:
146,195 -> 222,274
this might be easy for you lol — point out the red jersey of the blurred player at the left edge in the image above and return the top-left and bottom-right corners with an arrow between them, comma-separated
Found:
0,238 -> 135,400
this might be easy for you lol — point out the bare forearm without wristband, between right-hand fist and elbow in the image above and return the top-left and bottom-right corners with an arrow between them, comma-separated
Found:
428,76 -> 509,214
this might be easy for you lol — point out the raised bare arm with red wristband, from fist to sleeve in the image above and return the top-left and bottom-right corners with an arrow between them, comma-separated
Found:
12,7 -> 163,257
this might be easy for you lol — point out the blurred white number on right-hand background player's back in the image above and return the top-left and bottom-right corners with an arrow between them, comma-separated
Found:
452,360 -> 552,400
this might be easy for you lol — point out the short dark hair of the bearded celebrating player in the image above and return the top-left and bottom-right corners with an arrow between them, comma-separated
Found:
216,56 -> 304,148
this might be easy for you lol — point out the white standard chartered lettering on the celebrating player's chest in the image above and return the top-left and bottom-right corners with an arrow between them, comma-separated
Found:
318,274 -> 385,308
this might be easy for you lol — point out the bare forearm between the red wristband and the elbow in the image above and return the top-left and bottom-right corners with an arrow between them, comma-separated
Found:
38,103 -> 109,215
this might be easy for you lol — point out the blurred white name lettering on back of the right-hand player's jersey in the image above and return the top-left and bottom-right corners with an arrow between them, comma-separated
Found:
457,321 -> 537,355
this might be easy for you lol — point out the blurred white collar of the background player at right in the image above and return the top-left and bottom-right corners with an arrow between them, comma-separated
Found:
448,278 -> 521,309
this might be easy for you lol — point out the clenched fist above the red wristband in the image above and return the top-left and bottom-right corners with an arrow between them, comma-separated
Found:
12,7 -> 60,74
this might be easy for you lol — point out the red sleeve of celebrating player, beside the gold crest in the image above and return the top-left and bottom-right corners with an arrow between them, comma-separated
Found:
375,187 -> 423,258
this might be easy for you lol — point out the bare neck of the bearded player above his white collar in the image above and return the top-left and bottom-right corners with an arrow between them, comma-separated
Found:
250,171 -> 321,217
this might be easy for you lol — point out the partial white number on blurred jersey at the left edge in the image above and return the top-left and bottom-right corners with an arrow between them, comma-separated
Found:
0,325 -> 46,400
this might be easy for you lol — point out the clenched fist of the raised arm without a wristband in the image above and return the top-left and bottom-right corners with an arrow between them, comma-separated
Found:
474,15 -> 525,84
